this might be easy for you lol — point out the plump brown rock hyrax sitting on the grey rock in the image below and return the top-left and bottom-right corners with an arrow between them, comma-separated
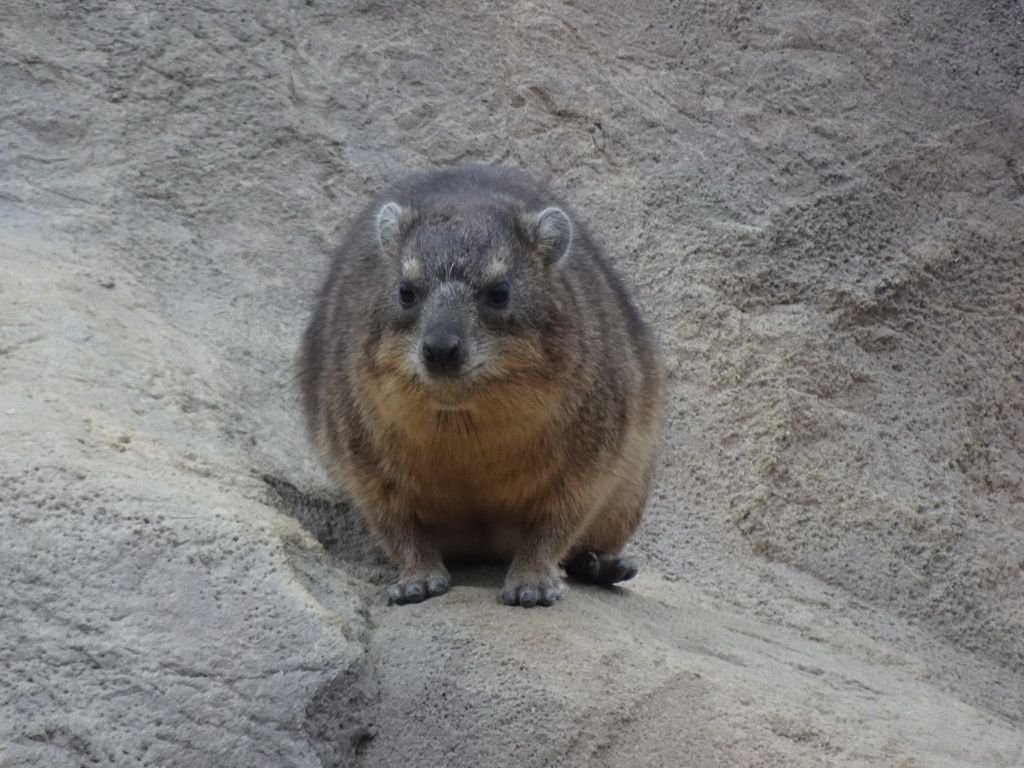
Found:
299,167 -> 664,606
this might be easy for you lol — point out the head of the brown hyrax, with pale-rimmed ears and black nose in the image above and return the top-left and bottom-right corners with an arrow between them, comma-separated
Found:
376,200 -> 572,406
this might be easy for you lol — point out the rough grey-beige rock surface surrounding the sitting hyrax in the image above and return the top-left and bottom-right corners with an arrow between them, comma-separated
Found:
0,0 -> 1024,768
